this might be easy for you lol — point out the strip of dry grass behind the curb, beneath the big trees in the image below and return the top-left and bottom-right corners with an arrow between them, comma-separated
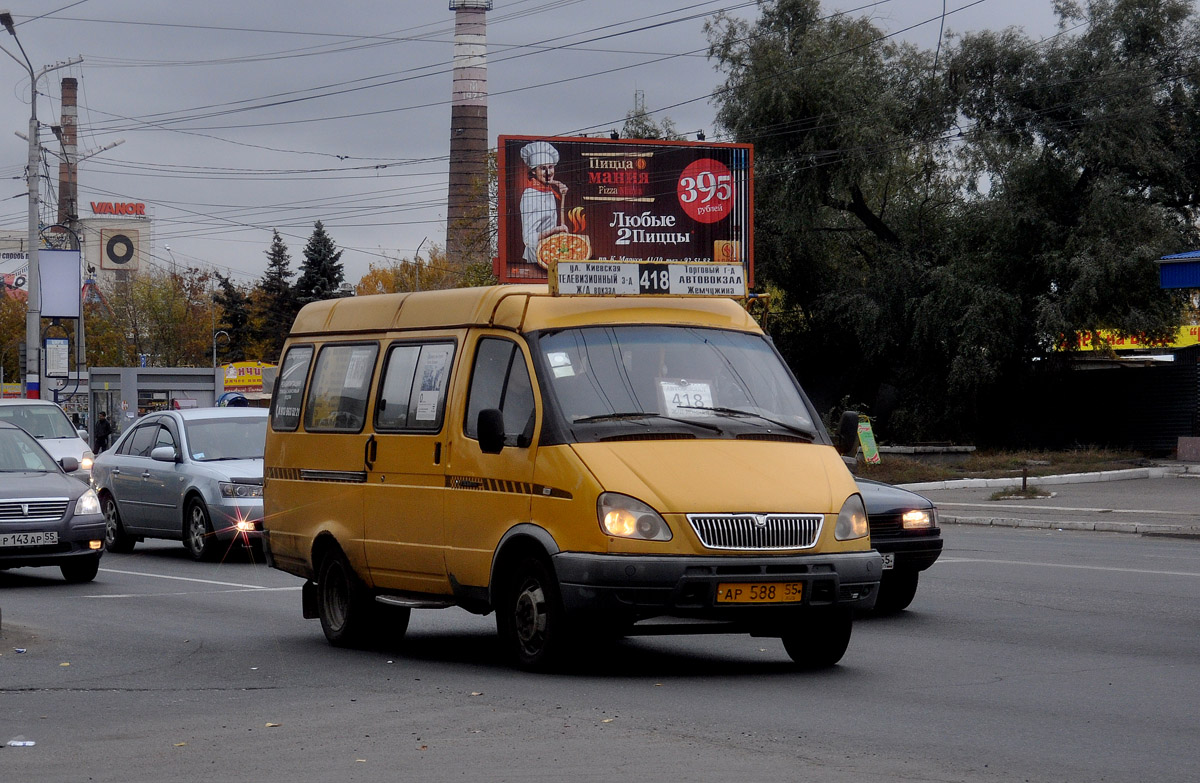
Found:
857,449 -> 1153,484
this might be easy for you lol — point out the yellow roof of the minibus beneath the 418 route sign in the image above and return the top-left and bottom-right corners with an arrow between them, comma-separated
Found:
285,286 -> 761,337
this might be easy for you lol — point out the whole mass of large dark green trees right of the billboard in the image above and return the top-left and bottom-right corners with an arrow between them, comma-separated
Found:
709,0 -> 1198,442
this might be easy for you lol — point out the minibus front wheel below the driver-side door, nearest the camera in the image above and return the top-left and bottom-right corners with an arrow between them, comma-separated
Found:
496,555 -> 570,671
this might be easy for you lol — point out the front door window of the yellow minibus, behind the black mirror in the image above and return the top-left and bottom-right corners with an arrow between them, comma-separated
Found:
463,337 -> 534,447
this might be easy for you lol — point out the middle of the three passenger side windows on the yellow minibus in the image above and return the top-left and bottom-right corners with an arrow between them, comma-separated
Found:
304,342 -> 379,432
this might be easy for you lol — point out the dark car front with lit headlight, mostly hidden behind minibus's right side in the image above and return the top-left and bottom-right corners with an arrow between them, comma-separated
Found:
856,478 -> 942,614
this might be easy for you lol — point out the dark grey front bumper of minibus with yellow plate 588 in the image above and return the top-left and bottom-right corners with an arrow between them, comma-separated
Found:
552,550 -> 883,620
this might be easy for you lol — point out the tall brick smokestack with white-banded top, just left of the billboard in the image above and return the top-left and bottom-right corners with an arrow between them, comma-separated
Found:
446,0 -> 492,265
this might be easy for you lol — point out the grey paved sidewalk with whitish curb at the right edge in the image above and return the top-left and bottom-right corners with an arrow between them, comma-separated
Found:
899,462 -> 1200,538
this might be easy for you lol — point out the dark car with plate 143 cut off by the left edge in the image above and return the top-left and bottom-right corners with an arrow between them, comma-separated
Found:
0,423 -> 104,582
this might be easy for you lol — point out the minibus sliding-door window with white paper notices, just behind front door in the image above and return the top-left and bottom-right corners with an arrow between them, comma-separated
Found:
376,342 -> 454,432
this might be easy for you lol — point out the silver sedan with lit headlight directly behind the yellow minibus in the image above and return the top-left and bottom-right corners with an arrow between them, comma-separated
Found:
91,408 -> 268,560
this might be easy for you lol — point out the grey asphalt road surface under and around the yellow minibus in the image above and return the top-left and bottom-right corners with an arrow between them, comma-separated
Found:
0,516 -> 1200,783
